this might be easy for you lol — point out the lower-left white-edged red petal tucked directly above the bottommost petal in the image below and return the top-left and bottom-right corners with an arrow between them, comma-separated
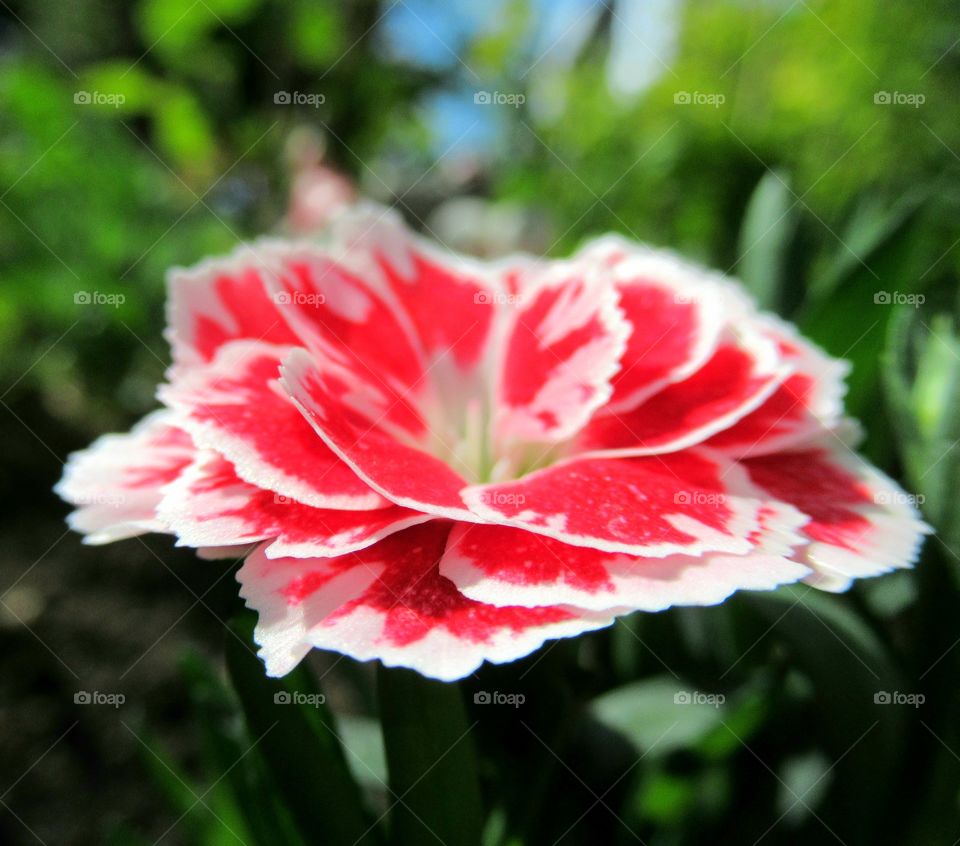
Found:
158,451 -> 432,558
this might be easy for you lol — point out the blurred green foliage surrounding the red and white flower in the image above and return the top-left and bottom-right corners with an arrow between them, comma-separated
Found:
0,0 -> 960,846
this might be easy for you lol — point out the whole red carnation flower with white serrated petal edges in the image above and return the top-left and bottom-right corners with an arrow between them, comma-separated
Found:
58,203 -> 926,680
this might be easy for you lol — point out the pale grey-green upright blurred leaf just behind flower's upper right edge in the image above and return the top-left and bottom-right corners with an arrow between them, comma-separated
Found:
737,171 -> 798,310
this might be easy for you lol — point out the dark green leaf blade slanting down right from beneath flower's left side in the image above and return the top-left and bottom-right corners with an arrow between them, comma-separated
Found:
227,621 -> 374,846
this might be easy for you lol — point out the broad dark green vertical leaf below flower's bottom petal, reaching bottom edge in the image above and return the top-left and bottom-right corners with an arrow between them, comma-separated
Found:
377,666 -> 483,846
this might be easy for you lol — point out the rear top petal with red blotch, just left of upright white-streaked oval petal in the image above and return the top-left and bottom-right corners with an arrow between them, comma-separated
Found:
331,207 -> 501,371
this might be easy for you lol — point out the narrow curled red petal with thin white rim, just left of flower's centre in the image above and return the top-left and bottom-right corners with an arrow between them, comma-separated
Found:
282,350 -> 477,520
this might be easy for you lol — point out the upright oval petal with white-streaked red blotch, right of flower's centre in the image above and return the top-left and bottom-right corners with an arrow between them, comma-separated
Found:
494,262 -> 630,441
